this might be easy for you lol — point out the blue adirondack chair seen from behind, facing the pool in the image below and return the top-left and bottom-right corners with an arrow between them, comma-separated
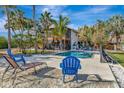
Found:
60,56 -> 81,82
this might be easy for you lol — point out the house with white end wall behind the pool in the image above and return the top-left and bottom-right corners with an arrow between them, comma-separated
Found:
41,26 -> 78,50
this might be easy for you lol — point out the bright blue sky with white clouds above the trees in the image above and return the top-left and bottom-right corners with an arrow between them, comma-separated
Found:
0,5 -> 124,37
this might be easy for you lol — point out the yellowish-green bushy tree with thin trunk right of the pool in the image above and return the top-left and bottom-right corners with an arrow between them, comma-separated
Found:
78,20 -> 108,62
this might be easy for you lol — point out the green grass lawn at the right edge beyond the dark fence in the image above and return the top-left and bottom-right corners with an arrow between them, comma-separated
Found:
108,52 -> 124,67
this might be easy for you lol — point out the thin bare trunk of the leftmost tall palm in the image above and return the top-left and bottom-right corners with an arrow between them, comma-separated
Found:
5,6 -> 11,49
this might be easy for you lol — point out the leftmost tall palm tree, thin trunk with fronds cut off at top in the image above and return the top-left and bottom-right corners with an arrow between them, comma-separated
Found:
2,5 -> 16,49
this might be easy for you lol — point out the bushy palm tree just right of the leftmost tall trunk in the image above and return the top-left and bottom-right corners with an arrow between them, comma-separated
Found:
10,9 -> 25,51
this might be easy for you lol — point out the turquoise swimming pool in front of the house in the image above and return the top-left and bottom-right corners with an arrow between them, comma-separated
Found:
56,51 -> 93,58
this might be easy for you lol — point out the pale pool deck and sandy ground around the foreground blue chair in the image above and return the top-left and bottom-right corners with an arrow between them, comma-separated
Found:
0,54 -> 118,88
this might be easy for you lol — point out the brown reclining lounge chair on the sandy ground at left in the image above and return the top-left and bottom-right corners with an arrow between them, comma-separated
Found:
2,55 -> 47,85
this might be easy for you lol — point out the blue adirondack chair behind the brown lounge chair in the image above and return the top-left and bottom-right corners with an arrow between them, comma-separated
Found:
7,49 -> 26,64
